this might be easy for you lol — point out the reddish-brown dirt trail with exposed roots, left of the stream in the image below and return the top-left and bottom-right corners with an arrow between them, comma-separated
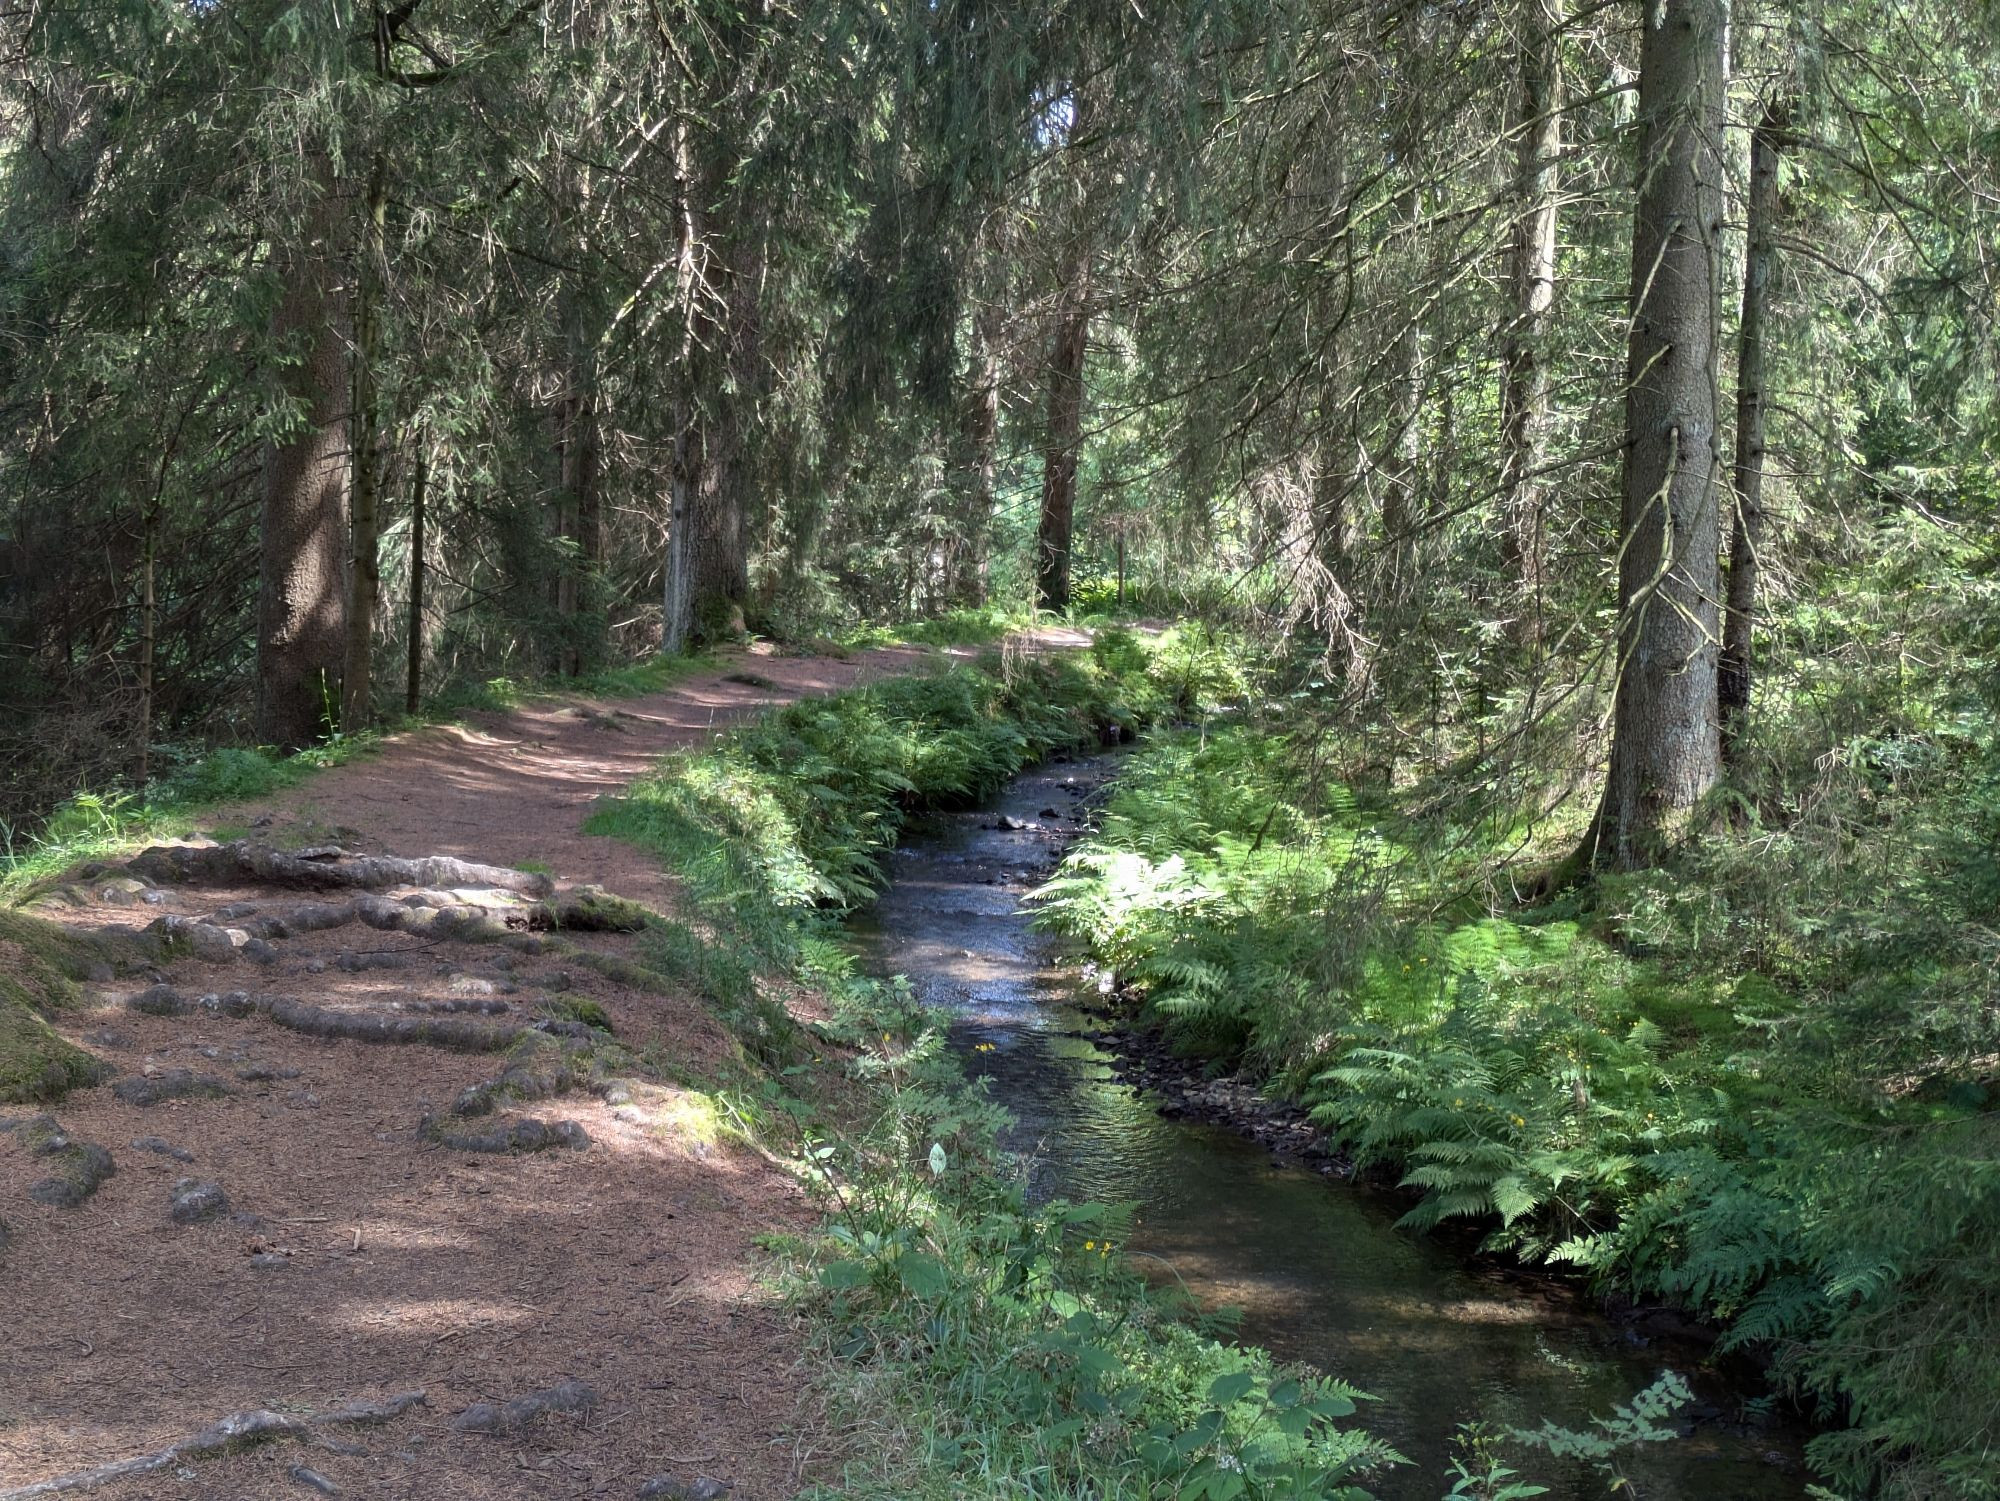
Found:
0,650 -> 1080,1501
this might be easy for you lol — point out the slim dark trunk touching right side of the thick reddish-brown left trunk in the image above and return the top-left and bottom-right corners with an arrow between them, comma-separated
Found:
340,148 -> 388,732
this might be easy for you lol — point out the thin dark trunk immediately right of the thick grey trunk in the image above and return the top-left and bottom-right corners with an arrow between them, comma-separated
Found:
1716,100 -> 1788,761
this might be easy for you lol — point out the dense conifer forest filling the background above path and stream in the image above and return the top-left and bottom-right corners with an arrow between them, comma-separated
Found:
0,0 -> 1996,836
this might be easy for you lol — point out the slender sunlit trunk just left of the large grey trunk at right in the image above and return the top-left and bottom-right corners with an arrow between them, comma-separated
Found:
1500,0 -> 1562,644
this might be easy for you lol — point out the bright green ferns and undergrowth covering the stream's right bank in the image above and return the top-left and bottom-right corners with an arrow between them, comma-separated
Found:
1046,720 -> 2000,1499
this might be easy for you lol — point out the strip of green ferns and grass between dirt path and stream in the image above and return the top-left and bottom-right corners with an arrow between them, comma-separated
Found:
590,632 -> 1488,1501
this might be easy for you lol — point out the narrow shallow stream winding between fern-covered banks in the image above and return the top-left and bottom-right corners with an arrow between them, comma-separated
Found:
854,755 -> 1806,1501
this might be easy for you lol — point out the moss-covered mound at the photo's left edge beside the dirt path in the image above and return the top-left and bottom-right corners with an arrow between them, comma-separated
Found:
0,911 -> 114,1105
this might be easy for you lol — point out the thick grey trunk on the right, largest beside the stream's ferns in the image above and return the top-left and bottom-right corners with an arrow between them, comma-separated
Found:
1584,0 -> 1728,867
